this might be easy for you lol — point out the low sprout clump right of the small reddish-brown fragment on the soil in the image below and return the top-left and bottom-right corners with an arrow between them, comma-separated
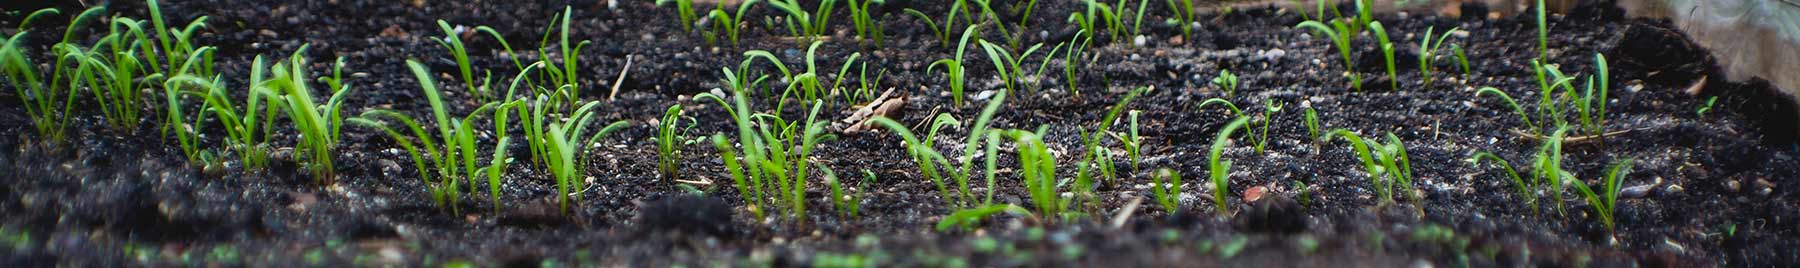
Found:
1325,130 -> 1413,205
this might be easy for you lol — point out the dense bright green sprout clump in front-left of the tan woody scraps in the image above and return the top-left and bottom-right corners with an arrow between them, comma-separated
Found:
695,83 -> 833,223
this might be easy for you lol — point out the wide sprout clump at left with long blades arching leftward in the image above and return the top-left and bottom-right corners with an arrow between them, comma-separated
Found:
346,59 -> 525,212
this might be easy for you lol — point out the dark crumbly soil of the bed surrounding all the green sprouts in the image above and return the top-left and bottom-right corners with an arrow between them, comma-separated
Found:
0,0 -> 1800,266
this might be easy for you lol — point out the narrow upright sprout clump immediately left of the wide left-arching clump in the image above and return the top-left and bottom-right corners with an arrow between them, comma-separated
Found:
265,45 -> 351,182
